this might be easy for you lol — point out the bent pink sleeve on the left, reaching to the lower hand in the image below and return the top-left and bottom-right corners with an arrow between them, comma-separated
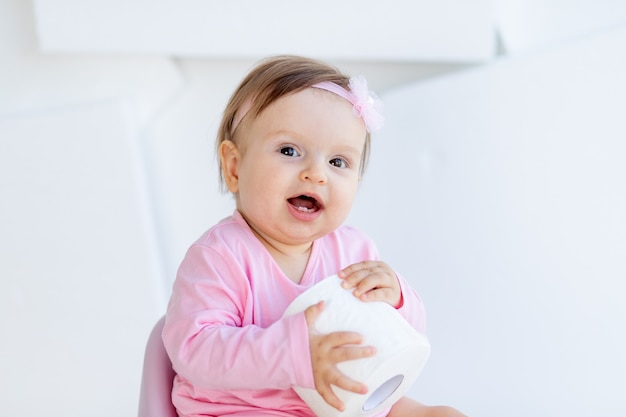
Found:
163,244 -> 314,390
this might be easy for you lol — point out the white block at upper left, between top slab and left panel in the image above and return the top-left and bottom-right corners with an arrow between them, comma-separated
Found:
0,0 -> 182,125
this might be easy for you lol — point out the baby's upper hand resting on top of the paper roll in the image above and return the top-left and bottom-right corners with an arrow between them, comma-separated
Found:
337,261 -> 402,308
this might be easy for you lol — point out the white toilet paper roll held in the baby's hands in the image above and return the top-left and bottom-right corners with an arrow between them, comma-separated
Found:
283,275 -> 430,417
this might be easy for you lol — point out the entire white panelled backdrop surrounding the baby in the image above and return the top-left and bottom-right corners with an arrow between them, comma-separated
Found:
0,0 -> 626,417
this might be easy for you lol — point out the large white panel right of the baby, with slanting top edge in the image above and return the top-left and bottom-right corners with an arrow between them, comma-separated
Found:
351,23 -> 626,416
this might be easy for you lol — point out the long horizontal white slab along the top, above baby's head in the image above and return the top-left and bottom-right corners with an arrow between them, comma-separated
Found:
35,0 -> 494,62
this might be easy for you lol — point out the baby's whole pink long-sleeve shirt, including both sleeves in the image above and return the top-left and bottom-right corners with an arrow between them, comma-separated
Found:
163,211 -> 425,417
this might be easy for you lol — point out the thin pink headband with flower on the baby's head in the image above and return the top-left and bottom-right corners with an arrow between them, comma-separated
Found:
230,77 -> 384,134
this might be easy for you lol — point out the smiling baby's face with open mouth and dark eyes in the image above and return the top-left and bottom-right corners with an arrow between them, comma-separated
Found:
231,88 -> 366,249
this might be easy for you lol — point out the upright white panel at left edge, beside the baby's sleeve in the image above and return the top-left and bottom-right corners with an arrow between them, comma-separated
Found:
0,103 -> 162,417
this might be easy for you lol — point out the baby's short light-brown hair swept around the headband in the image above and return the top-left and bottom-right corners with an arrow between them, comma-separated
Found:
215,55 -> 370,189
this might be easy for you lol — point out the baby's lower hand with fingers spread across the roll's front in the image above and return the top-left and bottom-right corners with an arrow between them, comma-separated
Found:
304,301 -> 376,411
